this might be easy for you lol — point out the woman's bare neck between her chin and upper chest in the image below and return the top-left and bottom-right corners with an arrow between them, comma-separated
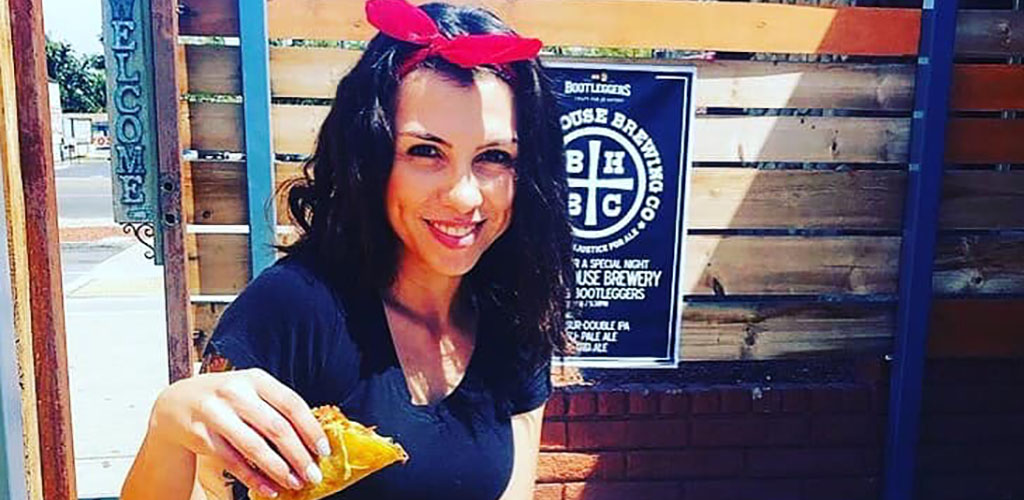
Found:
385,254 -> 462,332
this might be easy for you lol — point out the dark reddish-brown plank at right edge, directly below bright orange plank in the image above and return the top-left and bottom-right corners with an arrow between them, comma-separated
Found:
946,118 -> 1024,164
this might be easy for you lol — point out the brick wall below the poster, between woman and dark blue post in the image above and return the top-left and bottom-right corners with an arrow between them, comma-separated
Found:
537,381 -> 886,500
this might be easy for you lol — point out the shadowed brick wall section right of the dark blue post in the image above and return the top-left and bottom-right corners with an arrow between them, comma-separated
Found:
916,360 -> 1024,500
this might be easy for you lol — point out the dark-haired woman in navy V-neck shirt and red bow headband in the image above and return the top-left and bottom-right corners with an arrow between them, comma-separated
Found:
122,0 -> 572,499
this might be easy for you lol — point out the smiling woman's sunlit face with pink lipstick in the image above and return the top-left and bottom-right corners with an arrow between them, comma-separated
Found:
385,69 -> 517,278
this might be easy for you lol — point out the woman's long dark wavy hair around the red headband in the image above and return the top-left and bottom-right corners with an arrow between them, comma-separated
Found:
282,3 -> 574,366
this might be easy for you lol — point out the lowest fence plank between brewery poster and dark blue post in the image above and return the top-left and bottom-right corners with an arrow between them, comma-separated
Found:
680,302 -> 895,361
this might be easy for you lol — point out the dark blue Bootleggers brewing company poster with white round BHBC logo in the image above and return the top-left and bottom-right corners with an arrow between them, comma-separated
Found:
547,64 -> 695,368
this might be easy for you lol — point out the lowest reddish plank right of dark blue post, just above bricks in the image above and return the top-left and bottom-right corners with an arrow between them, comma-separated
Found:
928,299 -> 1024,359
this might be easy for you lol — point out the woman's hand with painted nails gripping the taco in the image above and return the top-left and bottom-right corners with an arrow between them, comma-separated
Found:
150,368 -> 331,497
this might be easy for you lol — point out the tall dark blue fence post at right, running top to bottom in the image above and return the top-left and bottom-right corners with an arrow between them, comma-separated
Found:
884,0 -> 957,500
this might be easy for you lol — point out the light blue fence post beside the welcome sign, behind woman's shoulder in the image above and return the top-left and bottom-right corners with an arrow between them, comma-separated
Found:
239,0 -> 276,278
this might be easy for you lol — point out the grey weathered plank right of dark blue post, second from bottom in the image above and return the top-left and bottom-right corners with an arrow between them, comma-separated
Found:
933,236 -> 1024,294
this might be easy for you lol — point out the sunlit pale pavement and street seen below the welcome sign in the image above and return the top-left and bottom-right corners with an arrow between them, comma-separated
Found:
56,161 -> 167,499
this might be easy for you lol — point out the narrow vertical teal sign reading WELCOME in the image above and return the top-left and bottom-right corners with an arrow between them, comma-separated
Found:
102,0 -> 157,226
